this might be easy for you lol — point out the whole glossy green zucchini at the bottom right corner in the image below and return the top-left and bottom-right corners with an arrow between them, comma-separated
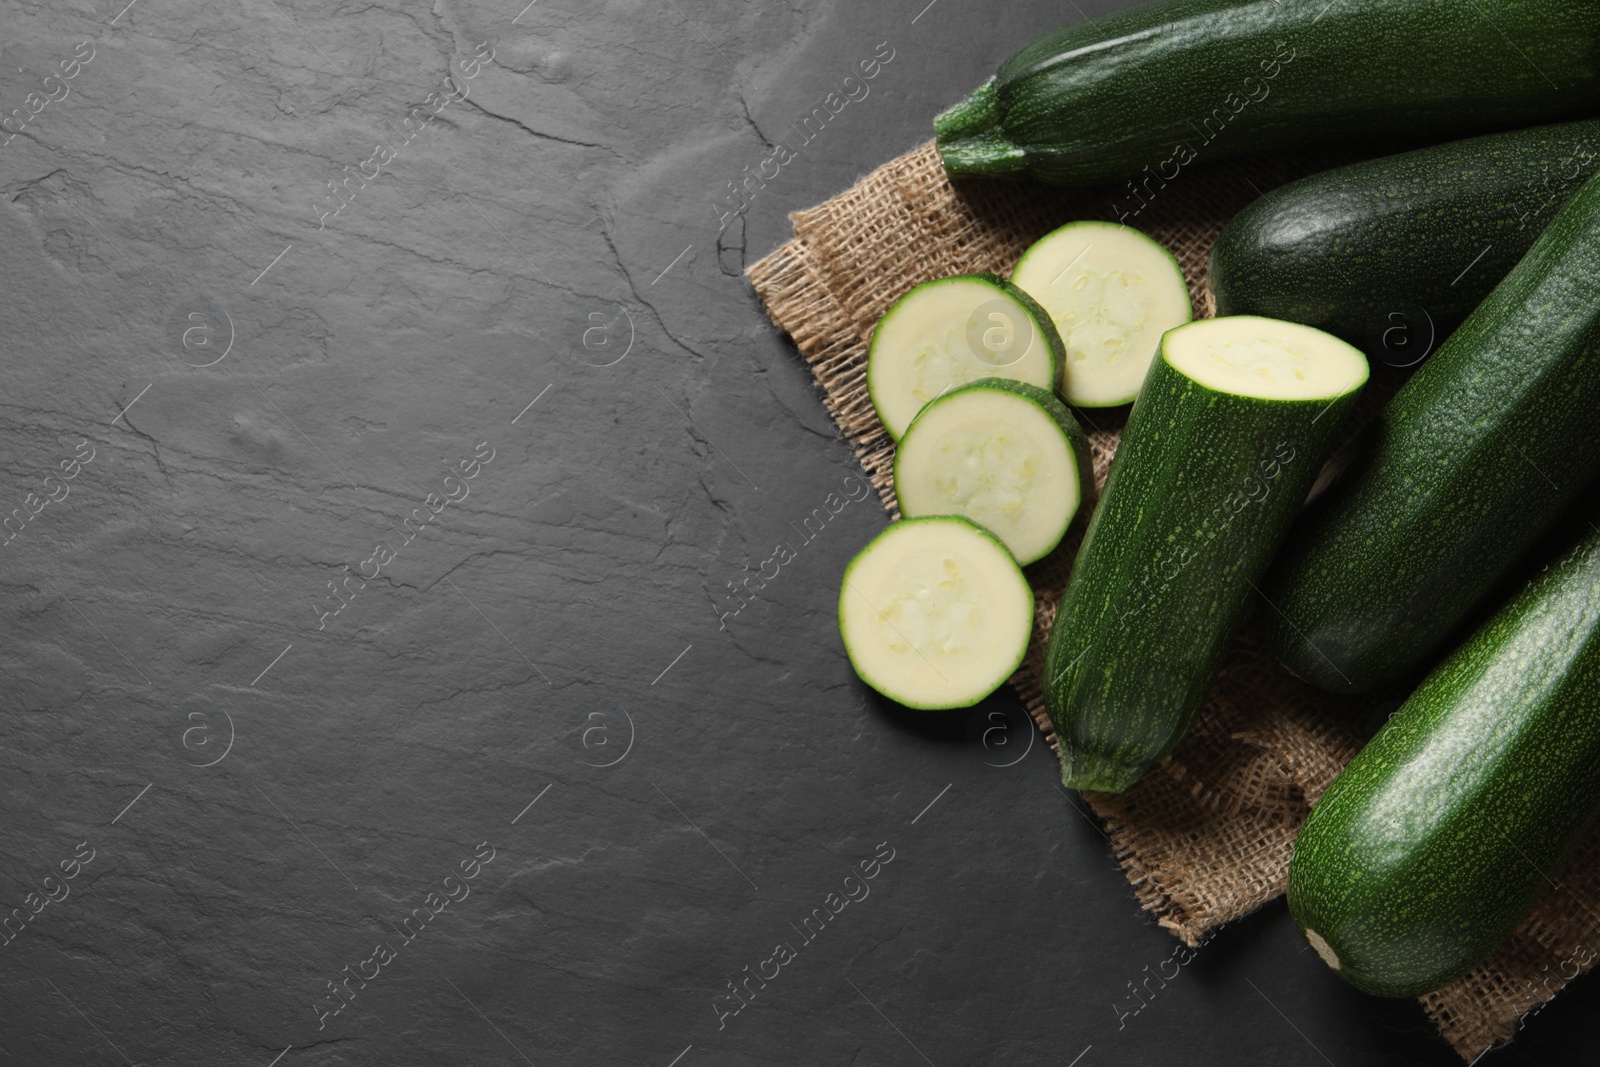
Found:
1288,518 -> 1600,997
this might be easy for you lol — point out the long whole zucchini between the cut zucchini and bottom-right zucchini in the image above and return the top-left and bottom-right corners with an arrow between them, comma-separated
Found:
1264,168 -> 1600,693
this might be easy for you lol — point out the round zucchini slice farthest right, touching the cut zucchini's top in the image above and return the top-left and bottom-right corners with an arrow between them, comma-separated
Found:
1011,222 -> 1194,408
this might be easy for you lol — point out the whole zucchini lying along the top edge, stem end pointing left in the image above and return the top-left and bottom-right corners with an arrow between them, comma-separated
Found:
934,0 -> 1600,187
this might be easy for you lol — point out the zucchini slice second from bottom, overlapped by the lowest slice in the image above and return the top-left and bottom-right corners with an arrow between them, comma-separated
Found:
894,378 -> 1094,565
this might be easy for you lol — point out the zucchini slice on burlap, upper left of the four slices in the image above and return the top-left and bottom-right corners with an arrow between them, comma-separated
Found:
867,274 -> 1061,442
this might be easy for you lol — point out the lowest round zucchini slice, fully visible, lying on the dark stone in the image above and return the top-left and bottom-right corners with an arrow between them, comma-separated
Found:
838,517 -> 1034,710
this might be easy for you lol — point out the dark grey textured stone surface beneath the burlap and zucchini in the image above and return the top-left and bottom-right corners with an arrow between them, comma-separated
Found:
0,0 -> 1595,1067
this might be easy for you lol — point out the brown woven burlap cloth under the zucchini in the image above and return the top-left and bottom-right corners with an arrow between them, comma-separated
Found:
749,135 -> 1600,1061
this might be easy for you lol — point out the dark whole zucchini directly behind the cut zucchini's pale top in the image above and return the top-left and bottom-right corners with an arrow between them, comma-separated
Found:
1209,118 -> 1600,347
